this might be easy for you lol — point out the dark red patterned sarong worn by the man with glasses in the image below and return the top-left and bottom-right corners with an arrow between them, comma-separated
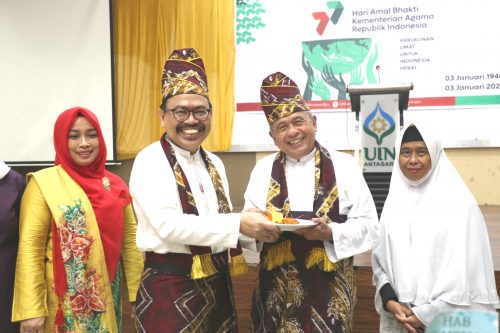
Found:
136,252 -> 238,333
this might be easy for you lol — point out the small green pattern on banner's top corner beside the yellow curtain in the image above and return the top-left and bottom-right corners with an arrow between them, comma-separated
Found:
236,0 -> 266,44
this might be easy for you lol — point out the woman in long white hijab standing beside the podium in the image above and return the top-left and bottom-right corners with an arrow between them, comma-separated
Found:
372,124 -> 499,333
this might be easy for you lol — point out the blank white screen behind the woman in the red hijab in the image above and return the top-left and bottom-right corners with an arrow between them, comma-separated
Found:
0,0 -> 114,164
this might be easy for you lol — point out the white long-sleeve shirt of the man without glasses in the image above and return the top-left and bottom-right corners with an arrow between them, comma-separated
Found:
245,150 -> 378,262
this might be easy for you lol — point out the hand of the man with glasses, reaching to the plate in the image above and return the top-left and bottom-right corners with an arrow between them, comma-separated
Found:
240,211 -> 281,243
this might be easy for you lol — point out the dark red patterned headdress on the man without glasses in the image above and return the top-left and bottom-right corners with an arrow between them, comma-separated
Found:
260,72 -> 309,125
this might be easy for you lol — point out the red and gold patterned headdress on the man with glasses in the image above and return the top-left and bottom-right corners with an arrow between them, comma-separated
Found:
162,48 -> 208,105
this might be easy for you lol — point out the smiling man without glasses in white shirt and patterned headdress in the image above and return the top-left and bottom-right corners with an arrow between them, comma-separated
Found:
245,72 -> 378,332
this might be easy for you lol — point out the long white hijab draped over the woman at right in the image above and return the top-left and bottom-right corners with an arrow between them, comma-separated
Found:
372,124 -> 498,313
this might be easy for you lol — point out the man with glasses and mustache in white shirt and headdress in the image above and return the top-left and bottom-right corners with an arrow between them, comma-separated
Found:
130,49 -> 280,333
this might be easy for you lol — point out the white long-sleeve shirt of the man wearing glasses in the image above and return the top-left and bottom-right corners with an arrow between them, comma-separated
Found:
130,141 -> 240,253
